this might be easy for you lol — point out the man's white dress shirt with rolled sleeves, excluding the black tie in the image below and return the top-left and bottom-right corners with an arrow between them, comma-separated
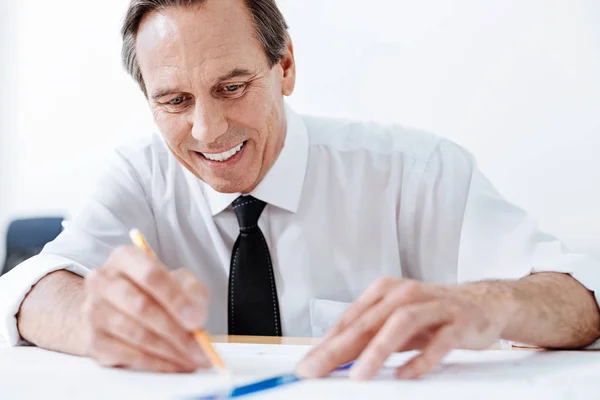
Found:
0,107 -> 600,345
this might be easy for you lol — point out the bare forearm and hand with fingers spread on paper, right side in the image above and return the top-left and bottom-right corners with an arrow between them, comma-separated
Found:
297,273 -> 600,379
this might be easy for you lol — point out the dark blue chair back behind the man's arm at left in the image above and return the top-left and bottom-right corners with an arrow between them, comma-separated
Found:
0,217 -> 63,275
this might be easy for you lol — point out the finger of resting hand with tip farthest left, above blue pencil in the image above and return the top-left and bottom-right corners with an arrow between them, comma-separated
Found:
297,283 -> 423,378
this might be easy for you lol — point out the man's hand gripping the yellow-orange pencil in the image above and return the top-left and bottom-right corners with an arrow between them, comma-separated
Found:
83,230 -> 222,372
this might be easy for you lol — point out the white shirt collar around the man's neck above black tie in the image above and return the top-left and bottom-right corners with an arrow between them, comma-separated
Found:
202,104 -> 308,216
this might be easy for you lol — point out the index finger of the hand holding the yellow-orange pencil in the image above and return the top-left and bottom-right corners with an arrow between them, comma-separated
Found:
105,246 -> 206,331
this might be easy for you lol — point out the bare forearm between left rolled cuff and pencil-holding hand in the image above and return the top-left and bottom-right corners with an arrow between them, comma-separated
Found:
17,270 -> 85,355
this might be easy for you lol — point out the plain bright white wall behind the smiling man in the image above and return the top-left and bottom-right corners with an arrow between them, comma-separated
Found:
0,0 -> 600,262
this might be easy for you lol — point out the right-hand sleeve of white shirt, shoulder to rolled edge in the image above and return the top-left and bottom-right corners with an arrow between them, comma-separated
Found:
410,141 -> 600,348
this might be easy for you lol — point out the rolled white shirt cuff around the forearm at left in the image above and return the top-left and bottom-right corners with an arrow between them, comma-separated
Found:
0,254 -> 89,346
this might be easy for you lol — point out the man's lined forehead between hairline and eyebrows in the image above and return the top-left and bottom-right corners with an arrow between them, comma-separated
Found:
136,0 -> 267,84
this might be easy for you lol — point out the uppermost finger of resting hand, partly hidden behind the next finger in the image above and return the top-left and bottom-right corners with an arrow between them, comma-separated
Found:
323,277 -> 401,340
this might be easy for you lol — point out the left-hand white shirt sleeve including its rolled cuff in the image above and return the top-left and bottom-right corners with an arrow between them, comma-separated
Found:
0,145 -> 156,346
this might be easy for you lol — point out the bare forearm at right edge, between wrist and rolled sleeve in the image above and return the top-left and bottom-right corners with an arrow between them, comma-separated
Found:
500,272 -> 600,349
